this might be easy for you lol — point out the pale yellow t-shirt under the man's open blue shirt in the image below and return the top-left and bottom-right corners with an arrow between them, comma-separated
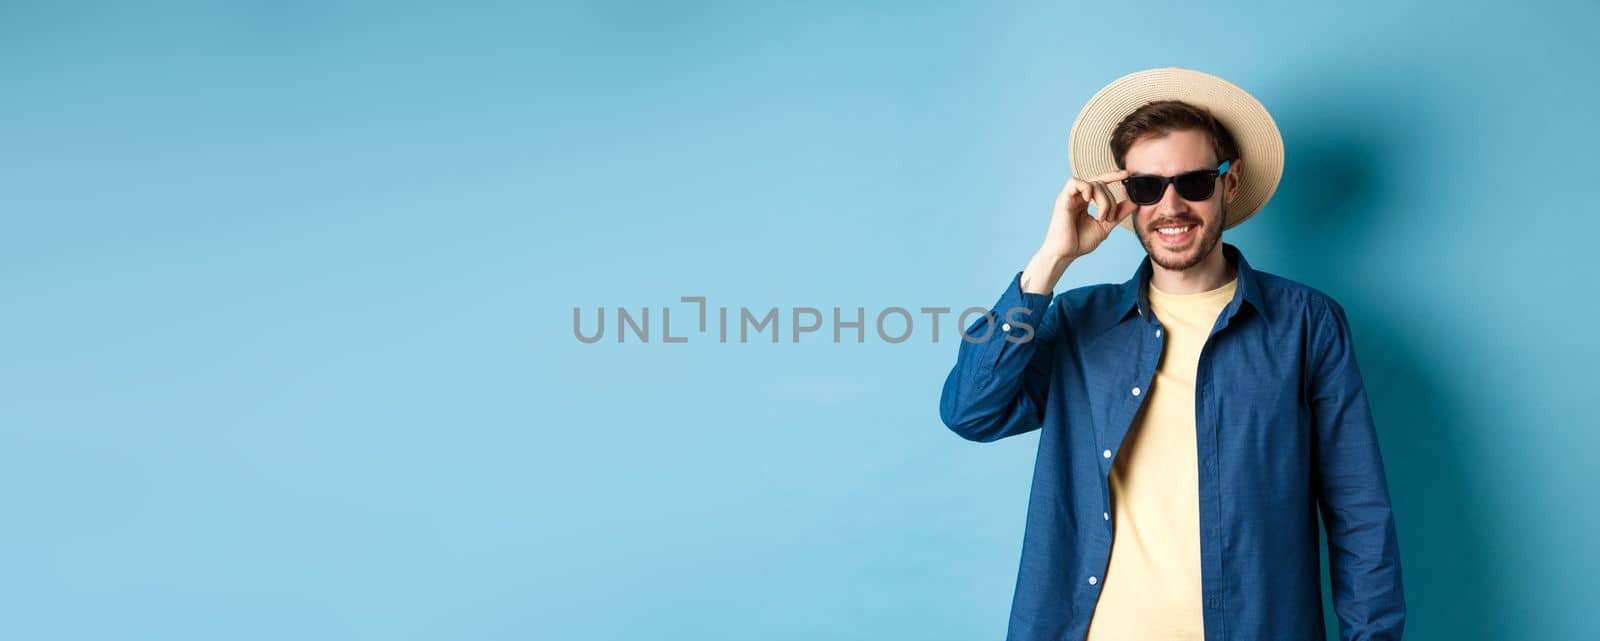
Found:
1086,277 -> 1238,641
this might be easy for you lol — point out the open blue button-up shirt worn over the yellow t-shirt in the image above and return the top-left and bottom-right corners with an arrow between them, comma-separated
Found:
939,243 -> 1405,641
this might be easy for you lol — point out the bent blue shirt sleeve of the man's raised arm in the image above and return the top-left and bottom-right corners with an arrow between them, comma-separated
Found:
939,272 -> 1066,443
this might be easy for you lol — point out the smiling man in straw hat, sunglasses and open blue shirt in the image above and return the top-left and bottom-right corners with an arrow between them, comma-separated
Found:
939,67 -> 1405,641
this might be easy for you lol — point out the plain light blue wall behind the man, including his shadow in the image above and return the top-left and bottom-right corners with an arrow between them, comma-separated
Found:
0,2 -> 1600,639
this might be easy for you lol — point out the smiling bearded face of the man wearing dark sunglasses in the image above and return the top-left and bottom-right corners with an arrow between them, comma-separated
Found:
1123,131 -> 1240,272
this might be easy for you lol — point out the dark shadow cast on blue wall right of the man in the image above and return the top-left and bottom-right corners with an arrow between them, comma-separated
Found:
1253,67 -> 1510,641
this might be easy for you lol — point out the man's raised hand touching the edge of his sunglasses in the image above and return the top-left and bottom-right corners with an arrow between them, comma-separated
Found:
1022,169 -> 1139,294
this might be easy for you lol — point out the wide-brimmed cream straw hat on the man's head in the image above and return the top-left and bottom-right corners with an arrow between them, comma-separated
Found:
1067,67 -> 1283,232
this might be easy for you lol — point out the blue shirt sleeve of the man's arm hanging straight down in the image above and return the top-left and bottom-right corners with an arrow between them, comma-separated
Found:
1307,299 -> 1405,641
